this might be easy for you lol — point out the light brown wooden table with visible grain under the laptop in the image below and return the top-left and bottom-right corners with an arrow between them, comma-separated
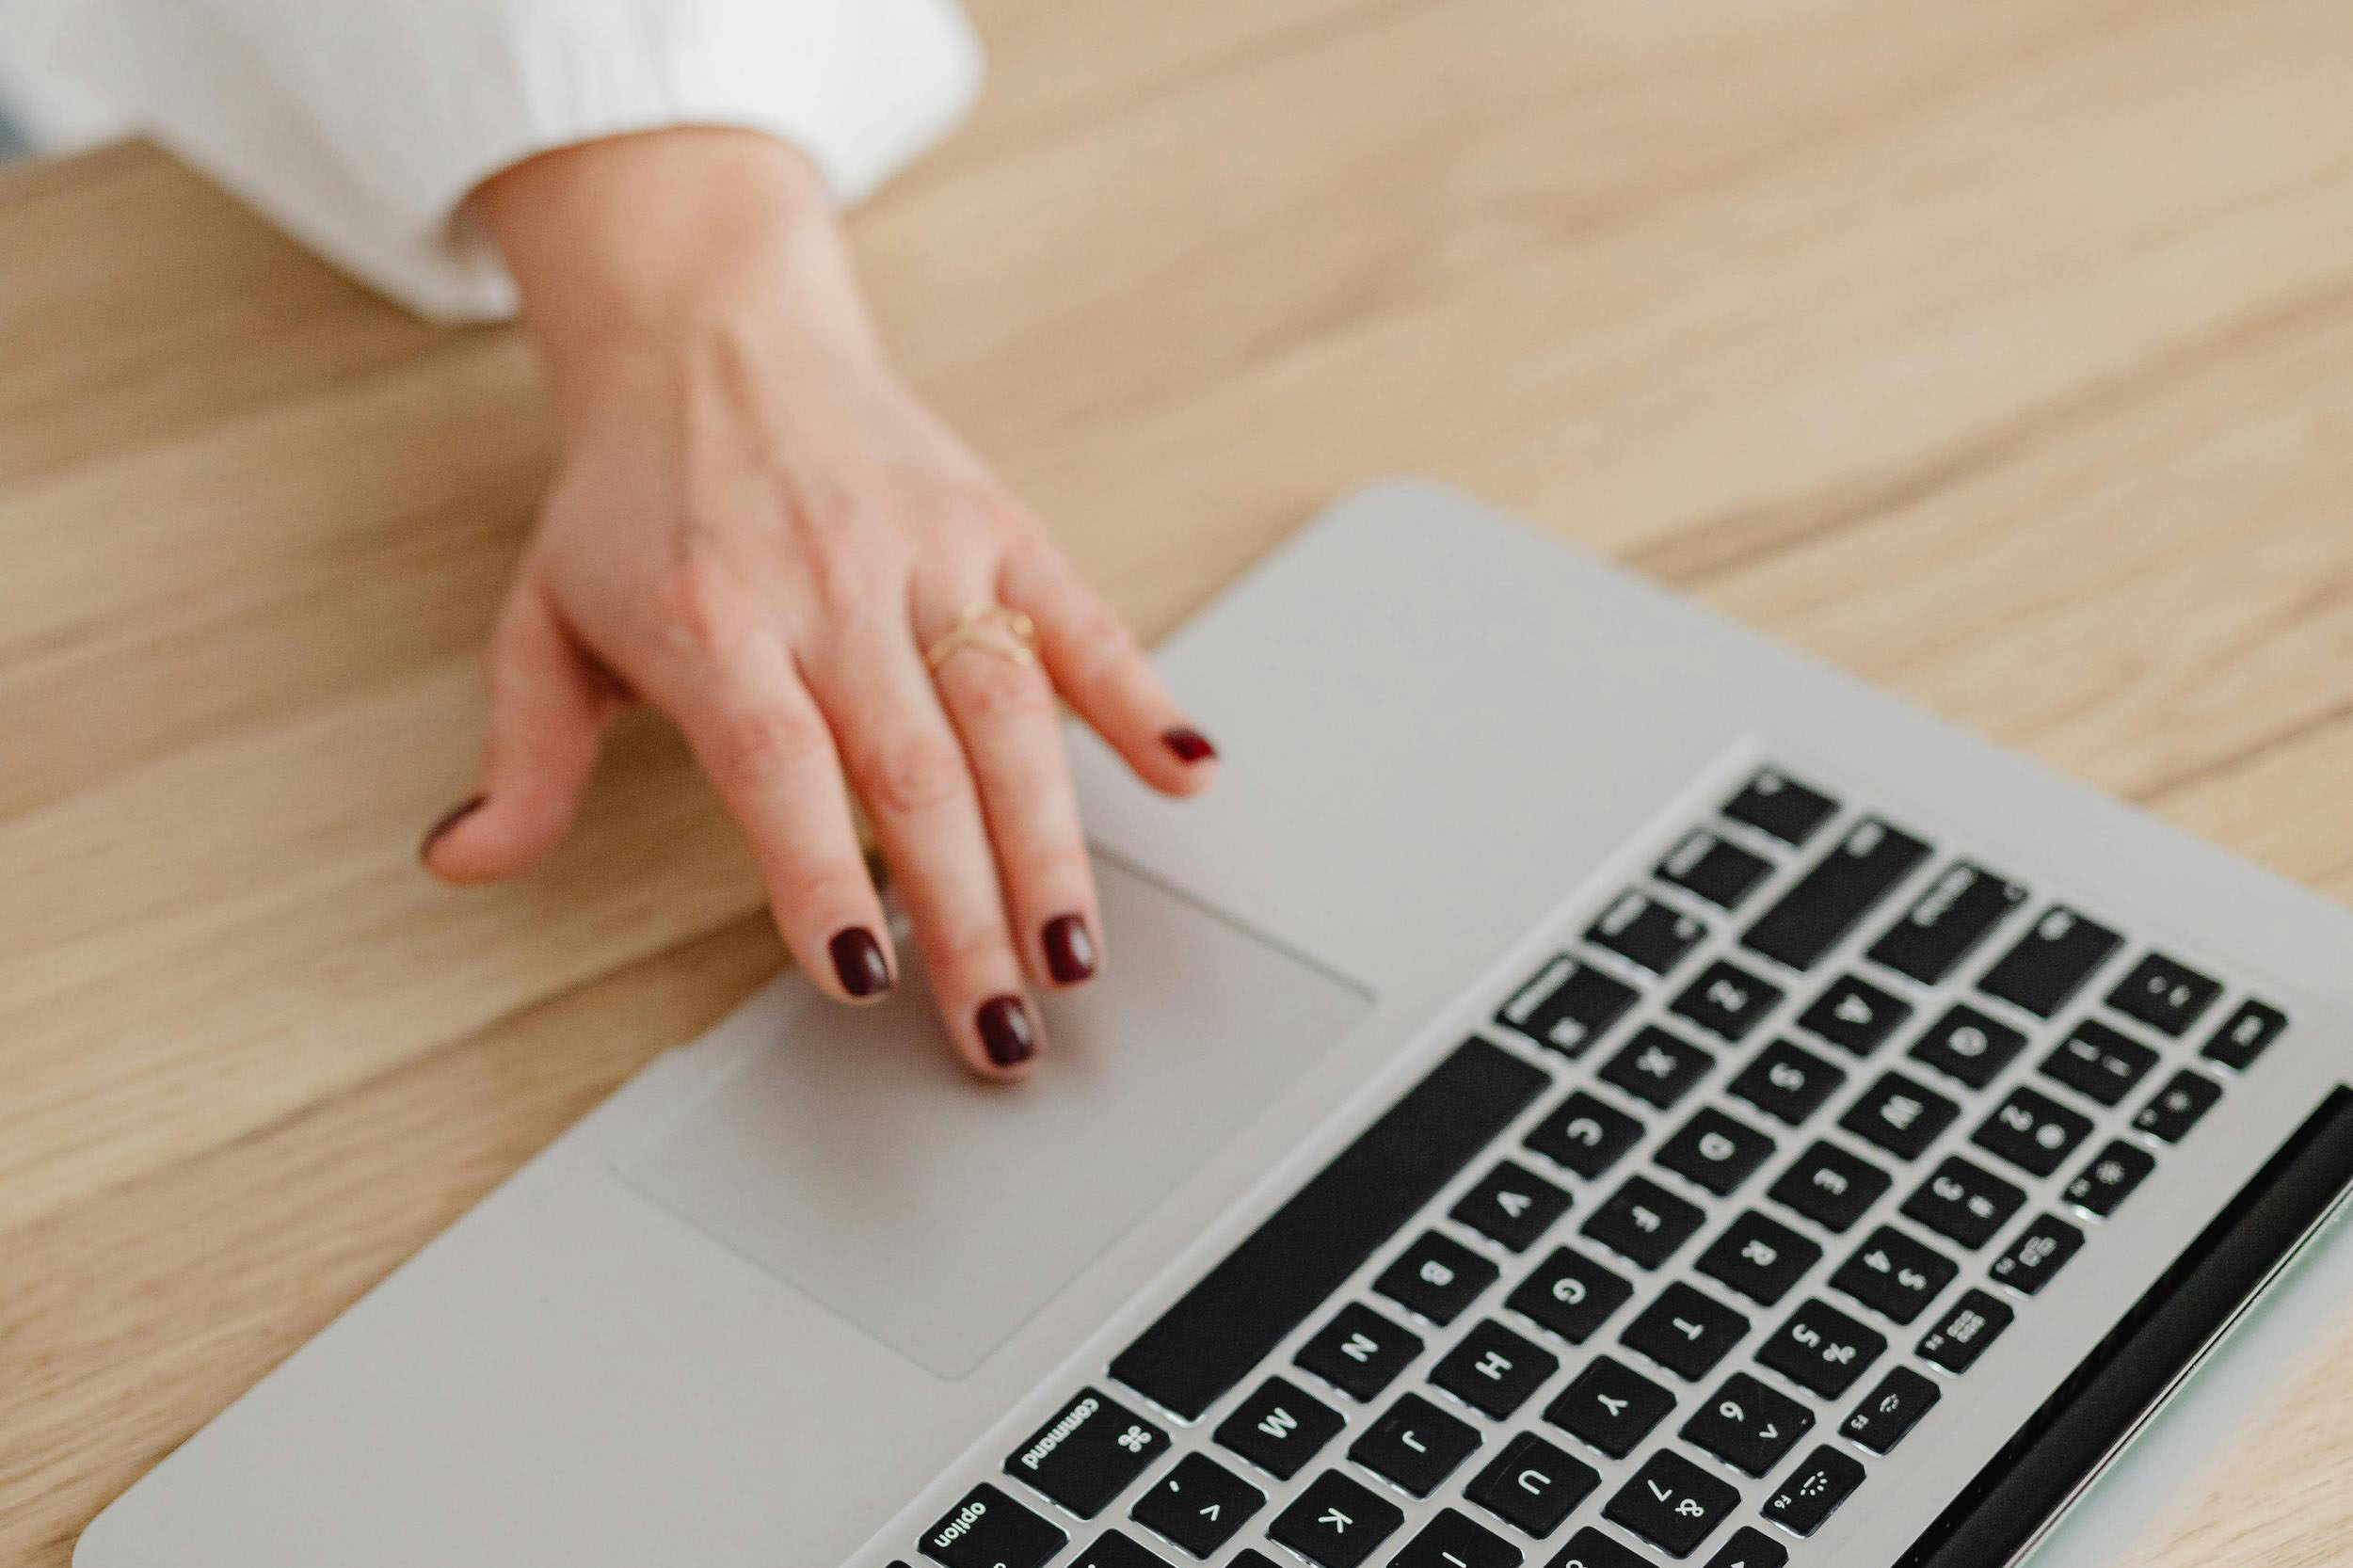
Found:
0,0 -> 2353,1568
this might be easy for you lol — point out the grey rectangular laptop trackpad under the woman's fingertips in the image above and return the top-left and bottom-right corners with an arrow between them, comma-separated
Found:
621,859 -> 1372,1377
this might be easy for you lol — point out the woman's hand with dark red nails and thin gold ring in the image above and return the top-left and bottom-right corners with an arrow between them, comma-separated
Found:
424,130 -> 1214,1079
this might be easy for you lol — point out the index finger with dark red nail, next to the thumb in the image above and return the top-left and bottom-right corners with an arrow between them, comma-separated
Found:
654,633 -> 897,1000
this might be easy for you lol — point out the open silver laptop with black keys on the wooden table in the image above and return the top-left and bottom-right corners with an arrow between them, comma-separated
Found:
75,485 -> 2353,1568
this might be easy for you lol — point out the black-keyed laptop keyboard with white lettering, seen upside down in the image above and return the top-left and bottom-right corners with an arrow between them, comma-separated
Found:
894,770 -> 2287,1568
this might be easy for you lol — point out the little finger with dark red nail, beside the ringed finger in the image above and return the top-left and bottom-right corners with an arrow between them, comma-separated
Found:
1005,549 -> 1217,796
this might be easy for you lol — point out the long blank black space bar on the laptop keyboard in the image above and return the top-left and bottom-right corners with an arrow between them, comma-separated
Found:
1111,1041 -> 1551,1419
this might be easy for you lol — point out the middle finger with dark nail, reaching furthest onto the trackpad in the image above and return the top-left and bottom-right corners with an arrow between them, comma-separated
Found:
812,610 -> 1038,1079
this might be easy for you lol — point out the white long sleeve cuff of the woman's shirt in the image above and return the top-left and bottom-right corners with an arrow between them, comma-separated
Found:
0,0 -> 982,320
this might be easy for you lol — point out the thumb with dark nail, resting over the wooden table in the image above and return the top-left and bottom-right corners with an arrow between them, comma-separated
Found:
419,577 -> 615,883
